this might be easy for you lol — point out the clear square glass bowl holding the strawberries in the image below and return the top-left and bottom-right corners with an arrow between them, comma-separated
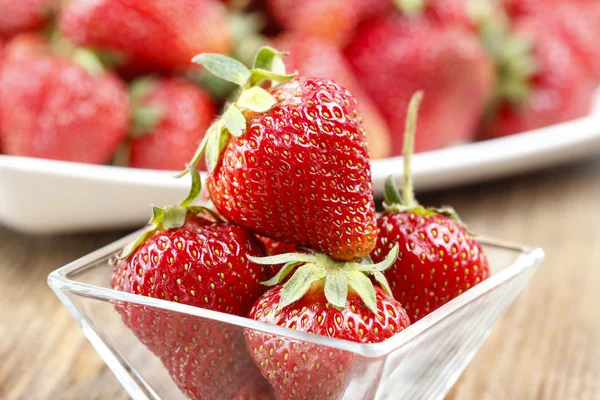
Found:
48,233 -> 544,400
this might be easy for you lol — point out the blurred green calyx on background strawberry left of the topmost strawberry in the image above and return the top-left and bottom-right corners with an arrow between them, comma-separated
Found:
129,76 -> 164,138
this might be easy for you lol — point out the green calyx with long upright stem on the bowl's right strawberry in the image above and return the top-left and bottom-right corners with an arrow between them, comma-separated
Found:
383,91 -> 464,226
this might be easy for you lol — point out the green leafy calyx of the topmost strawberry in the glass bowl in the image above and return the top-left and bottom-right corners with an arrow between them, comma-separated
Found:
177,46 -> 296,177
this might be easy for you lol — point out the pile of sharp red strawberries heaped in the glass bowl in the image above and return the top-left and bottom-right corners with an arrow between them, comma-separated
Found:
112,47 -> 490,400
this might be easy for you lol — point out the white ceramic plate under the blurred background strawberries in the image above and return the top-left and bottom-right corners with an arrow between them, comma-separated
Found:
0,112 -> 600,234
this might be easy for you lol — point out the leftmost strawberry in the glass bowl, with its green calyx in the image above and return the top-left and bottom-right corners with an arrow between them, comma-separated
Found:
112,170 -> 264,399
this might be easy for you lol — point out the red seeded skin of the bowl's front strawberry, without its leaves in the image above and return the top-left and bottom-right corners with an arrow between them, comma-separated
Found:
245,283 -> 410,400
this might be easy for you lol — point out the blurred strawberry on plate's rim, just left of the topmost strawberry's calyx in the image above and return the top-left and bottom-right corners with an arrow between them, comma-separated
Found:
128,78 -> 216,170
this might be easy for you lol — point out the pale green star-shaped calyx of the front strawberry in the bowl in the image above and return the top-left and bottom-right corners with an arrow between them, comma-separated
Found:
248,244 -> 399,313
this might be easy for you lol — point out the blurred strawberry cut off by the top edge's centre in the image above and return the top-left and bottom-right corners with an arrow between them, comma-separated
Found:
267,0 -> 362,47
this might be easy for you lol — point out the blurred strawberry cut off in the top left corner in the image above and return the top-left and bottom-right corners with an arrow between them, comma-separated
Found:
0,0 -> 58,36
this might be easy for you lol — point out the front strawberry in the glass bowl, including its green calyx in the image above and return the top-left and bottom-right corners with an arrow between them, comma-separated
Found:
245,246 -> 410,400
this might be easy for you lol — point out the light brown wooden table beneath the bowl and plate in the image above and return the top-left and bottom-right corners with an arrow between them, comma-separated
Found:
0,159 -> 600,400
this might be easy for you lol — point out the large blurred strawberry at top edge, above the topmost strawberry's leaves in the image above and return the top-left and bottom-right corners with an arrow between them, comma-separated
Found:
59,0 -> 231,71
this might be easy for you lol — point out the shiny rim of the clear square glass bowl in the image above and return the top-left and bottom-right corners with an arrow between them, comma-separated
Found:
48,230 -> 544,358
